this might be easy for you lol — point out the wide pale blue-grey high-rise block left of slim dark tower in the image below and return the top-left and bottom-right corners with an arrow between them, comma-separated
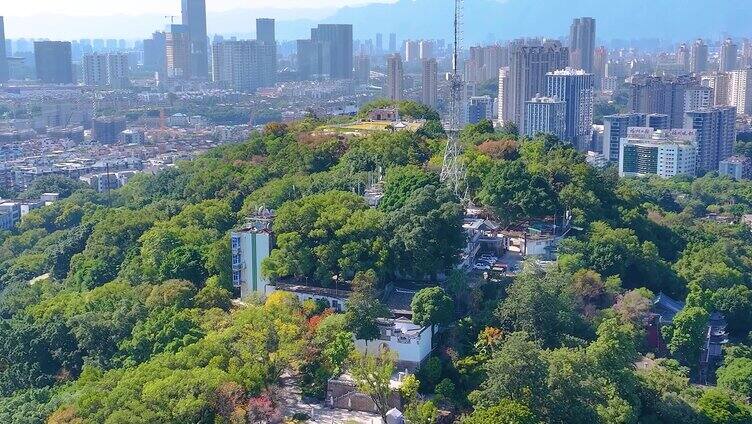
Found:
212,40 -> 273,92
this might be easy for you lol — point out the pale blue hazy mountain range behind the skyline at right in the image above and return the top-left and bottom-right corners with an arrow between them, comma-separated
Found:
326,0 -> 752,42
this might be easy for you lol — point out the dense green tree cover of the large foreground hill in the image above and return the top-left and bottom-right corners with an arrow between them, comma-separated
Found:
0,107 -> 752,424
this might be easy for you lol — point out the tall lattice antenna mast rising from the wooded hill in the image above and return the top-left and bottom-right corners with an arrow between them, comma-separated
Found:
441,0 -> 466,199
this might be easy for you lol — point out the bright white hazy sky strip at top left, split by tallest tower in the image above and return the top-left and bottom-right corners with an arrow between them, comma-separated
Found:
0,0 -> 392,16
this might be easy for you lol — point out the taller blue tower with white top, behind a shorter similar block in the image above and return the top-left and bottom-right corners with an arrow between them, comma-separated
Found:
546,68 -> 595,152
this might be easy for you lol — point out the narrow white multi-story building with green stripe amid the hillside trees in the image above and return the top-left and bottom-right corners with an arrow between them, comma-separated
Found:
230,210 -> 274,299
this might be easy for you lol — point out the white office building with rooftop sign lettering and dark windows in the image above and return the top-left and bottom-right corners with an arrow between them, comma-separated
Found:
619,127 -> 697,178
